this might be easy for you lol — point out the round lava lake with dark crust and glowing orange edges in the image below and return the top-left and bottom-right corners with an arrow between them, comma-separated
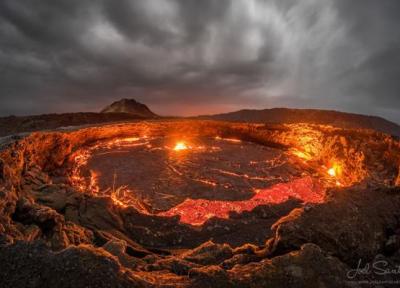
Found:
72,132 -> 323,225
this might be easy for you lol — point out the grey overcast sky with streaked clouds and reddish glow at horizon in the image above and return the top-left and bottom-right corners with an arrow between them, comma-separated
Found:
0,0 -> 400,123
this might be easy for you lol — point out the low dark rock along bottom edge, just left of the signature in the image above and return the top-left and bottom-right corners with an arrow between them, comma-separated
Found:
189,244 -> 354,288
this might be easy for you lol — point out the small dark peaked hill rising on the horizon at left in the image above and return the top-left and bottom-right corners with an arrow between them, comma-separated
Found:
100,98 -> 158,118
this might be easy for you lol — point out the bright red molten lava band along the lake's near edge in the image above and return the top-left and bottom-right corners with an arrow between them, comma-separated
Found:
158,177 -> 325,226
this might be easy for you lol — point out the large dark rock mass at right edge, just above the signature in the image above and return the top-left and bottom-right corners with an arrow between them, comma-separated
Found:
268,187 -> 400,266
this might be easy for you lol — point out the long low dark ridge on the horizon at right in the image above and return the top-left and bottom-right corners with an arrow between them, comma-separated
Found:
200,108 -> 400,137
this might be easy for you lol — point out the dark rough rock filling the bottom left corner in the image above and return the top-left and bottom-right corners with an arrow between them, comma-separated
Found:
0,242 -> 150,288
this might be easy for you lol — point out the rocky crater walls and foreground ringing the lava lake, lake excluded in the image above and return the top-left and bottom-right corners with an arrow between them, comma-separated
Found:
0,121 -> 400,287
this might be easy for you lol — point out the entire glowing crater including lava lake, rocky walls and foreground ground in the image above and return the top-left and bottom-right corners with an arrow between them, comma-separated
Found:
0,120 -> 400,287
